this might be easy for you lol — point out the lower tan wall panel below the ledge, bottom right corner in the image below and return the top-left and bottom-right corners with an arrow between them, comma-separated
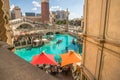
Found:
100,50 -> 120,80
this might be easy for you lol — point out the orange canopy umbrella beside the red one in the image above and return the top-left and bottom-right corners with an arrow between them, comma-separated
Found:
60,51 -> 81,66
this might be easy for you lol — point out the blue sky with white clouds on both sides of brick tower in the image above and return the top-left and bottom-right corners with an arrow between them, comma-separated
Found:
10,0 -> 84,19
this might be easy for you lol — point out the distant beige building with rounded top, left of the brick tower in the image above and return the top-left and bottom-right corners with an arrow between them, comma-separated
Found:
11,6 -> 22,19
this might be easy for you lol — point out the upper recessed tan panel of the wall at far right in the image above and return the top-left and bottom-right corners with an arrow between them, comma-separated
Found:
105,0 -> 120,44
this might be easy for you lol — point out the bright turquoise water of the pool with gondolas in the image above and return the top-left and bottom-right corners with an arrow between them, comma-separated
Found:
15,34 -> 82,62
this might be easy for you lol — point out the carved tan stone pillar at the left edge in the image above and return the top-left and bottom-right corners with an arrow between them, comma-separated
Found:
0,0 -> 12,44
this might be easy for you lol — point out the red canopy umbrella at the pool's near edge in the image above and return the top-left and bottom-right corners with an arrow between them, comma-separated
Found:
31,52 -> 57,65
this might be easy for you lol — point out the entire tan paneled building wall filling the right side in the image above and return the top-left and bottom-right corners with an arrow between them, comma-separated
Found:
81,0 -> 120,80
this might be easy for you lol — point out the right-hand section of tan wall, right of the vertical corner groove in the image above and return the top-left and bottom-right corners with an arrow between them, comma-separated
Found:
100,0 -> 120,80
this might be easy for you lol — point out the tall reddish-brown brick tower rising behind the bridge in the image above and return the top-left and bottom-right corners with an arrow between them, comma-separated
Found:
41,0 -> 49,23
